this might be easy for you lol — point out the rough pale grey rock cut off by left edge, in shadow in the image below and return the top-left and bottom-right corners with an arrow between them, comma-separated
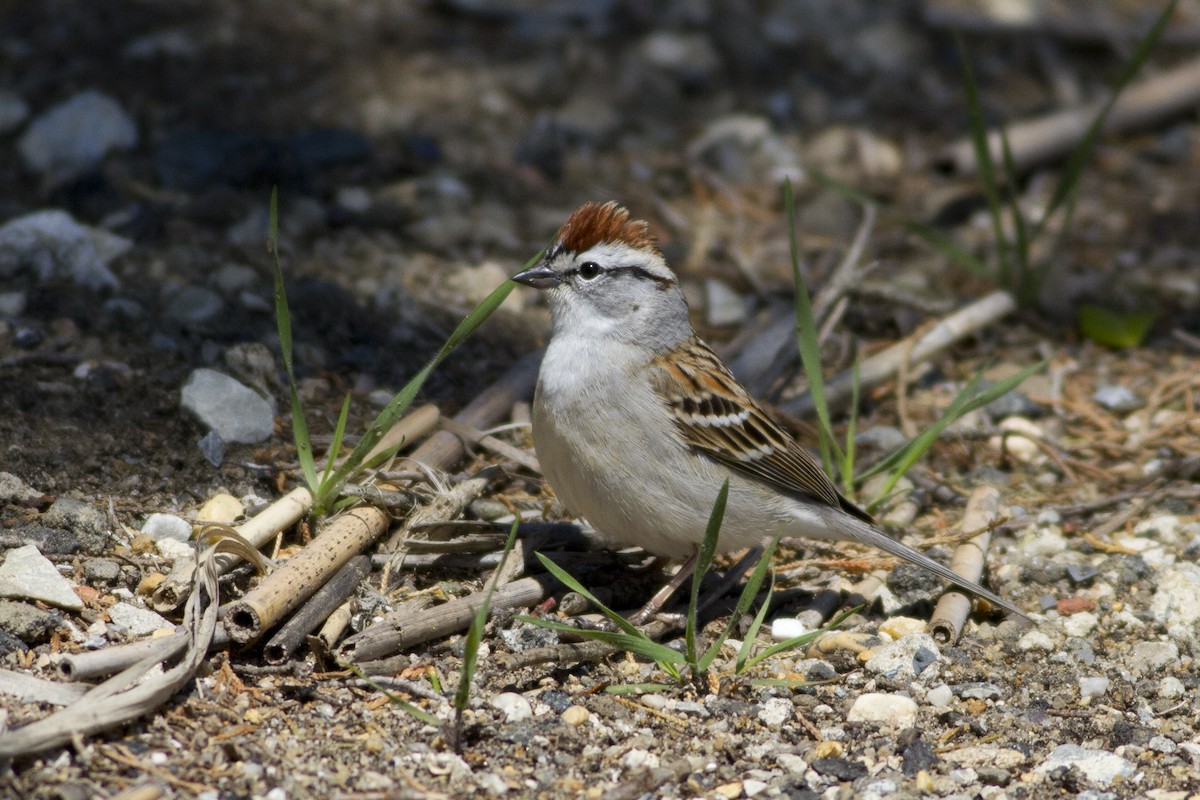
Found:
0,210 -> 133,290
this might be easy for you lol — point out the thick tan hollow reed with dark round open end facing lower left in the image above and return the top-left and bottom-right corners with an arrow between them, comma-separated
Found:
224,506 -> 391,644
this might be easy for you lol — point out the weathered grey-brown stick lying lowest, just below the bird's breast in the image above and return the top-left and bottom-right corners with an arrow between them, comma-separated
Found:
338,573 -> 558,674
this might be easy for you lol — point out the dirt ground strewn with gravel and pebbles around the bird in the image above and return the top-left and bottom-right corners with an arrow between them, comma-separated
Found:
0,0 -> 1200,800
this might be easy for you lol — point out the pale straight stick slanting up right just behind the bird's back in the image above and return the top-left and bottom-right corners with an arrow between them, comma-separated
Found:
780,290 -> 1016,416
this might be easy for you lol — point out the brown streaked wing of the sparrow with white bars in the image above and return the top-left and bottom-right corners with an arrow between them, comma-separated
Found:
654,337 -> 840,517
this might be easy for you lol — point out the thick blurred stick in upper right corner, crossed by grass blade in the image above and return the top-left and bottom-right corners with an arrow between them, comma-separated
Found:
938,59 -> 1200,174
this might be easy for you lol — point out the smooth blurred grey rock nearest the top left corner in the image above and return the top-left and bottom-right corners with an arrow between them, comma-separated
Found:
17,91 -> 138,182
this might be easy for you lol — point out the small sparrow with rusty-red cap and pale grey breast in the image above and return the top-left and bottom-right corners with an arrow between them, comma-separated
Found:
512,201 -> 1028,619
